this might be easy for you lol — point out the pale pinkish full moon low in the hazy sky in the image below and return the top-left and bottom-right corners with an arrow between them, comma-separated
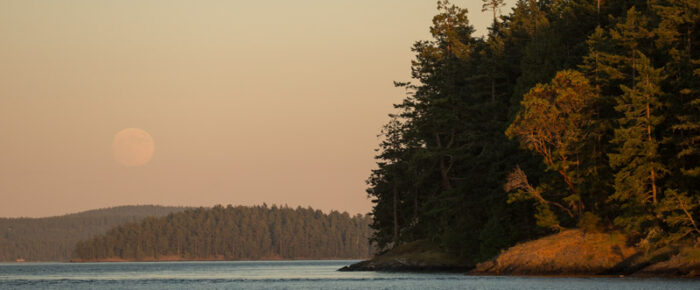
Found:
112,128 -> 155,167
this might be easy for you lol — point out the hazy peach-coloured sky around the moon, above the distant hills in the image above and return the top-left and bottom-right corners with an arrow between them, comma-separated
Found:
0,0 -> 513,217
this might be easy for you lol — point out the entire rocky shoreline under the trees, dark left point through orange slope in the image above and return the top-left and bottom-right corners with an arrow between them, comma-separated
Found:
339,230 -> 700,278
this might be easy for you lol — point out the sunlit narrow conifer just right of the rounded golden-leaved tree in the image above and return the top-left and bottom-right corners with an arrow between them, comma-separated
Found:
610,51 -> 667,238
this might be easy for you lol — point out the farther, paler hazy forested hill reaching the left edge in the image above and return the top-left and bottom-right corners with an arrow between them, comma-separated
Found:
0,205 -> 187,261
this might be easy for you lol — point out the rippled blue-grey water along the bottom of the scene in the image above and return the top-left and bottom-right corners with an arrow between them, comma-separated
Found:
0,261 -> 700,290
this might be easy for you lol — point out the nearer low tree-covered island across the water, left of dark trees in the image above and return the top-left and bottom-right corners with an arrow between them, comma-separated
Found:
75,205 -> 372,261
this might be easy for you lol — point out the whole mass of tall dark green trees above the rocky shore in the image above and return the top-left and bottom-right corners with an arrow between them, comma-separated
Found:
367,0 -> 700,262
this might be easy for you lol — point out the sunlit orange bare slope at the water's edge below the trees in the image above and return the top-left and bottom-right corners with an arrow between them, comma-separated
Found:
470,230 -> 700,277
